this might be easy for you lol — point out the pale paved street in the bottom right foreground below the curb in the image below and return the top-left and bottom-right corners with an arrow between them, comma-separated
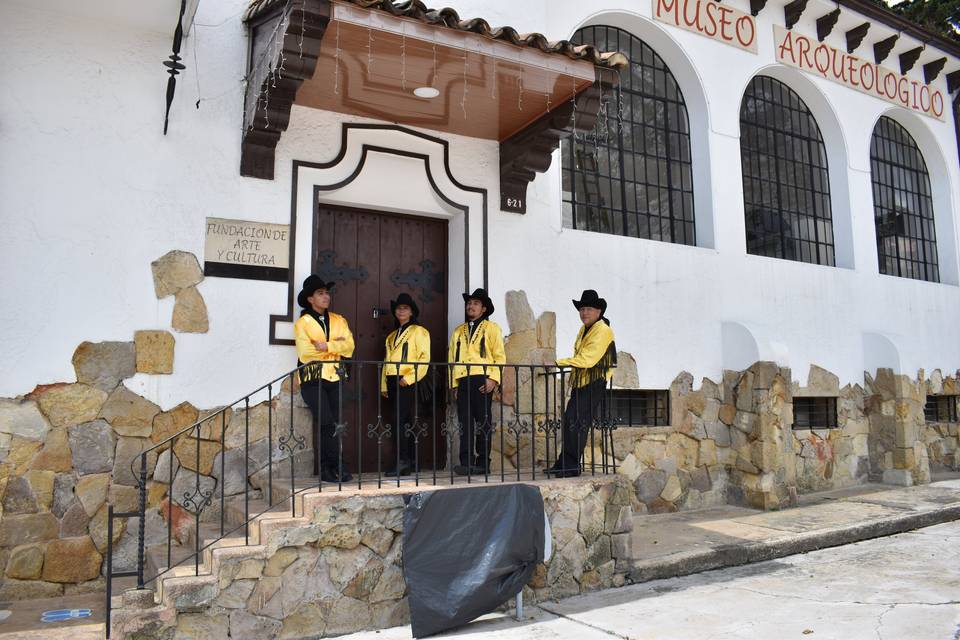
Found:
346,521 -> 960,640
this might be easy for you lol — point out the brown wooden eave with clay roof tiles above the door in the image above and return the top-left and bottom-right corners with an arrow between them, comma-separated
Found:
240,0 -> 628,208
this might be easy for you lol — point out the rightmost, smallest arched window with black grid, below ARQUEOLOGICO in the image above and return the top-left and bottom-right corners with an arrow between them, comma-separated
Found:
870,117 -> 940,282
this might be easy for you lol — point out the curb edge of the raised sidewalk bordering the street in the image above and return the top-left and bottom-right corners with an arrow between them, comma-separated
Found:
627,505 -> 960,584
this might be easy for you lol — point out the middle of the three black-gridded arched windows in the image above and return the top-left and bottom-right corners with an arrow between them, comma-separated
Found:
740,76 -> 835,266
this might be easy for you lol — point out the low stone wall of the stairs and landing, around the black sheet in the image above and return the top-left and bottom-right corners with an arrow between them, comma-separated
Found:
113,476 -> 633,638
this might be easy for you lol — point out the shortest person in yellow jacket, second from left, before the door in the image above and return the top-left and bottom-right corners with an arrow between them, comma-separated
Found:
380,293 -> 430,476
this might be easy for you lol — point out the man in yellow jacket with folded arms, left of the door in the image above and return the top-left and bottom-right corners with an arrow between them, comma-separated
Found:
293,275 -> 354,482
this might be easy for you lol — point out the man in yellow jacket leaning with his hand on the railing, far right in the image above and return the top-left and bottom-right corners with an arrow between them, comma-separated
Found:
546,289 -> 617,478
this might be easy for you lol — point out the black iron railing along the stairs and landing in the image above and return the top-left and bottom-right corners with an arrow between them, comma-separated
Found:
106,360 -> 618,637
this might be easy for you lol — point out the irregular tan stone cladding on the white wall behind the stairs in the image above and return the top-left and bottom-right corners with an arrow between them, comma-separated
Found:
0,246 -> 292,600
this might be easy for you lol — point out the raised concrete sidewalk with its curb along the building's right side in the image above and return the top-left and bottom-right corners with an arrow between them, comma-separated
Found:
629,475 -> 960,582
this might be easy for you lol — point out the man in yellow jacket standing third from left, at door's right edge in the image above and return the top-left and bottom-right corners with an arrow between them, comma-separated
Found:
448,289 -> 507,476
